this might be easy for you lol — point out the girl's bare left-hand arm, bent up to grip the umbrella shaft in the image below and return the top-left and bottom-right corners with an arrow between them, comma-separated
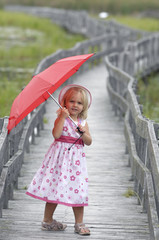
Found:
52,108 -> 69,139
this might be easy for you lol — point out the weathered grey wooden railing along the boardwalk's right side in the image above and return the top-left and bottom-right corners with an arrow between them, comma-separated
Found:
105,34 -> 159,240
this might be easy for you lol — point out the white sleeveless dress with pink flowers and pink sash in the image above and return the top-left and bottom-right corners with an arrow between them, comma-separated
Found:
26,118 -> 88,207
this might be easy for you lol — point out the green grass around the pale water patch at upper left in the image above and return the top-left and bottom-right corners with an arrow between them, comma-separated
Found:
0,11 -> 84,68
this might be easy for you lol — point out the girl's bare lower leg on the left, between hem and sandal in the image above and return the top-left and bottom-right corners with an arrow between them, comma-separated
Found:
43,202 -> 57,223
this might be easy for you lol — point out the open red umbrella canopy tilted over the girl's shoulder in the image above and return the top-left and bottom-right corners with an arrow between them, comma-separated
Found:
7,53 -> 94,133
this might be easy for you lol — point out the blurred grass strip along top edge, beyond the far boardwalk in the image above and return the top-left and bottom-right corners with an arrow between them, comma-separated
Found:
2,0 -> 159,14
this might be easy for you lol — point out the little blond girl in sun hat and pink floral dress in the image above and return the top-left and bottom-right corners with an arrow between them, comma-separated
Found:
27,84 -> 92,235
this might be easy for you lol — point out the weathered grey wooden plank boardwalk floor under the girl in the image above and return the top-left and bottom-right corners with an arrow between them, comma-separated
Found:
0,65 -> 150,240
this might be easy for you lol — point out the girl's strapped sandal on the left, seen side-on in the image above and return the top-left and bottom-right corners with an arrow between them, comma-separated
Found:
41,220 -> 67,231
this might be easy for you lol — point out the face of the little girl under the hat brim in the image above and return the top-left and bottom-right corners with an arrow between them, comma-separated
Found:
66,92 -> 83,120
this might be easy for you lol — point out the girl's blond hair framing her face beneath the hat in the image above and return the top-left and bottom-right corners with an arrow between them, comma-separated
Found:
61,87 -> 88,119
